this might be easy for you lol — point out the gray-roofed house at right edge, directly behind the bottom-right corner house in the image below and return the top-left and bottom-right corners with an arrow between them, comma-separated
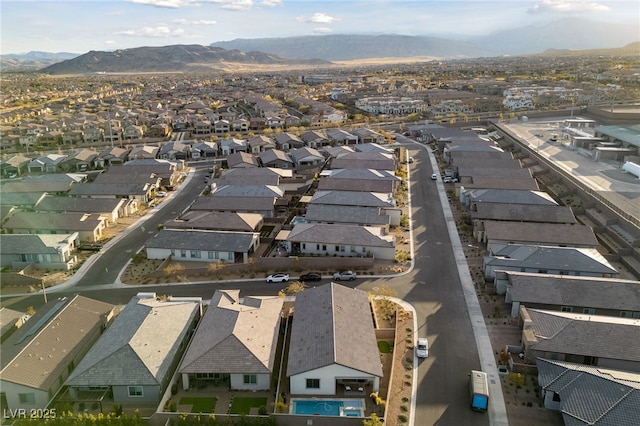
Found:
520,306 -> 640,373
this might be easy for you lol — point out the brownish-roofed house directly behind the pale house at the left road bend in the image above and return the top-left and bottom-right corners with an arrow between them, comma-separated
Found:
164,210 -> 264,232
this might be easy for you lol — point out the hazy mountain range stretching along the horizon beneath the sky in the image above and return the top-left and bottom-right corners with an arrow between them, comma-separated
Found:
0,19 -> 640,74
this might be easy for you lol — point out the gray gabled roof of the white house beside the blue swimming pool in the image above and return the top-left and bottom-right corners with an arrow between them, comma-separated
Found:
287,283 -> 382,377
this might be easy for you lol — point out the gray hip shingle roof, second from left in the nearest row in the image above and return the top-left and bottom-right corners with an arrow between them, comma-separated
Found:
67,297 -> 200,386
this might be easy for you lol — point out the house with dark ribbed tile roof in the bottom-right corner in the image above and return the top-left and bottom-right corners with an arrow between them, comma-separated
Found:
536,358 -> 640,426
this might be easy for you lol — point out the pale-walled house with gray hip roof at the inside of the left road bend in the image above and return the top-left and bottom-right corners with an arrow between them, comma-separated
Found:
146,229 -> 260,263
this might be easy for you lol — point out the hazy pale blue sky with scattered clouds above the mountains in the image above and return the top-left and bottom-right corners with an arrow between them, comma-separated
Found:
0,0 -> 640,54
